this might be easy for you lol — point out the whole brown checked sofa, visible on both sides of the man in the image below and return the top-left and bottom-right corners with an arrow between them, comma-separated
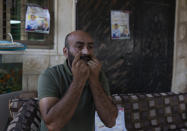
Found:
7,92 -> 187,131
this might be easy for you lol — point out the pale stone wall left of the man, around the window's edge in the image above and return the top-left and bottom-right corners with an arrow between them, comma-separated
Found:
0,0 -> 75,90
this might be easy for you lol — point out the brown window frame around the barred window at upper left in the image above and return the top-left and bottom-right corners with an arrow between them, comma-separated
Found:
0,0 -> 55,49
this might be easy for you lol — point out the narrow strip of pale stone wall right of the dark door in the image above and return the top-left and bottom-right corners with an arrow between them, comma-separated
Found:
172,0 -> 187,92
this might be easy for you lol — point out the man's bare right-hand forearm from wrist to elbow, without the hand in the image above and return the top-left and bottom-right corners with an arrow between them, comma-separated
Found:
90,80 -> 118,127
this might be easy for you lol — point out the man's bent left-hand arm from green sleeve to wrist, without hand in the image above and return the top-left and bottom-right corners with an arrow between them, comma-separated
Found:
39,82 -> 83,131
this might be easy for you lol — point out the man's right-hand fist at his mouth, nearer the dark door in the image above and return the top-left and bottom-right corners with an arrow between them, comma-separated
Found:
88,56 -> 101,81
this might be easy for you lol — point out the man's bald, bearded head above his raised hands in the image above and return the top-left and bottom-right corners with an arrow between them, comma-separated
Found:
63,30 -> 94,66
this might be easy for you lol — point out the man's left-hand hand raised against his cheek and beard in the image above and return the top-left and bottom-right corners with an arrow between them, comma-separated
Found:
71,53 -> 90,87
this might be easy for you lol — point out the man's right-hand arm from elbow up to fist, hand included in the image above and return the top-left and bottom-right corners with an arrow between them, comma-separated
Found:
88,58 -> 118,128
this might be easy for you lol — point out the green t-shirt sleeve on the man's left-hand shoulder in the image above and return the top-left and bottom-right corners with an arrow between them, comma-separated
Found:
38,68 -> 59,99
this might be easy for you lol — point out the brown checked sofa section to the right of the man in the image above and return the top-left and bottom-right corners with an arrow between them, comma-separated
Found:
113,92 -> 187,131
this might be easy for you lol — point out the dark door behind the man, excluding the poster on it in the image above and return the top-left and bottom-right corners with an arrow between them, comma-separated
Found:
76,0 -> 175,93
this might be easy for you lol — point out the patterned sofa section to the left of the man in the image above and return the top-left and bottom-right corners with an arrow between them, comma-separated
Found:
7,99 -> 41,131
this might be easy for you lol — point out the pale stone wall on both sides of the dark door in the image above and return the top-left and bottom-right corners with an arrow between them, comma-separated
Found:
0,0 -> 187,92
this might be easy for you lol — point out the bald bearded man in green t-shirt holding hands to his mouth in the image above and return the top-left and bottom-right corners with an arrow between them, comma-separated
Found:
38,31 -> 117,131
